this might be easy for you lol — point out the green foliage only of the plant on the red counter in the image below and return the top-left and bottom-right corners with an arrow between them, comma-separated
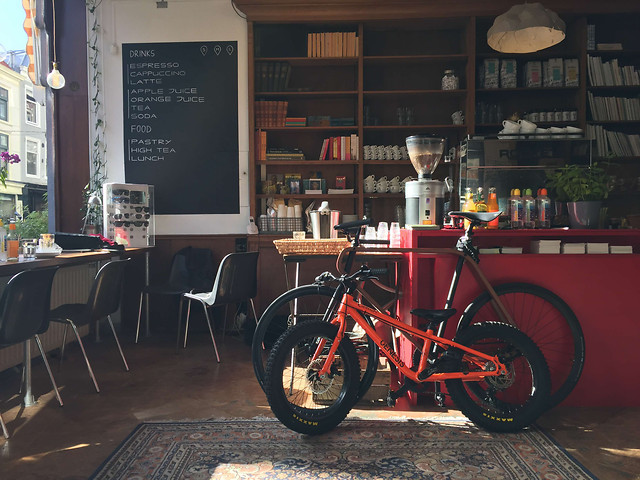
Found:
548,163 -> 609,202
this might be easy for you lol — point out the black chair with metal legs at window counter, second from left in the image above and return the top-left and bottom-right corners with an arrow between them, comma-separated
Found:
49,258 -> 130,393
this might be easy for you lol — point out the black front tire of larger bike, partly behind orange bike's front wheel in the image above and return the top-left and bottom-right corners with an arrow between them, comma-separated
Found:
251,285 -> 380,402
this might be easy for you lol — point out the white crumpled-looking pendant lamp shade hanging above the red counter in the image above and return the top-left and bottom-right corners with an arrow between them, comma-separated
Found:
487,3 -> 566,53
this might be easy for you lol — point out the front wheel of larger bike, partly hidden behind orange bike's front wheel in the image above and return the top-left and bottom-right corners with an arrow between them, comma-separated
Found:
251,285 -> 379,401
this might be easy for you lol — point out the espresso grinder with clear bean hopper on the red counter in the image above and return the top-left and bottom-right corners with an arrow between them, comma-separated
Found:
404,135 -> 451,228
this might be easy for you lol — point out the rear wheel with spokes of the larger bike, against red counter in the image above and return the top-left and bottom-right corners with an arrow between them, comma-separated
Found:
458,283 -> 585,408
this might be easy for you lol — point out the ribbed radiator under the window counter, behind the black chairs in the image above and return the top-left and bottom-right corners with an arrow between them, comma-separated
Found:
0,263 -> 96,371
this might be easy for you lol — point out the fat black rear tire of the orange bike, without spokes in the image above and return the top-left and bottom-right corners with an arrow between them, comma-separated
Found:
445,322 -> 551,433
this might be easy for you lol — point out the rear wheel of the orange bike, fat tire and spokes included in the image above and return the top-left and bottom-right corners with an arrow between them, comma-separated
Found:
445,322 -> 551,432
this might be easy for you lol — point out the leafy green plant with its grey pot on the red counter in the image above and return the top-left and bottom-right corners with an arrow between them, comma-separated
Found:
549,163 -> 609,228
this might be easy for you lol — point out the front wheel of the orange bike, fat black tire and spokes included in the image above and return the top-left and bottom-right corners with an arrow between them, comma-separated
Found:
265,320 -> 360,435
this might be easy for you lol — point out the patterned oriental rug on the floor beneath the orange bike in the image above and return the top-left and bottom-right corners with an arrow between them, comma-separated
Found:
91,418 -> 595,480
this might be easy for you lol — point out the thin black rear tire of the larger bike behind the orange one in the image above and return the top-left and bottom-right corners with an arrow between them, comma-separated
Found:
458,282 -> 585,408
